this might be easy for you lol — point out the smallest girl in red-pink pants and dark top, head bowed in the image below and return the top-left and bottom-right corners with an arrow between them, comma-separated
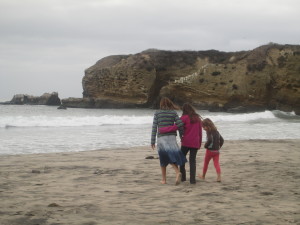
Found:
199,118 -> 224,182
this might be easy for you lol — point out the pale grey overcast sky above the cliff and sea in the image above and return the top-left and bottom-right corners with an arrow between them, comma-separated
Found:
0,0 -> 300,101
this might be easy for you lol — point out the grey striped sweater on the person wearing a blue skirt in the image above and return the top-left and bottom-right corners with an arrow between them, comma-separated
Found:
151,110 -> 183,145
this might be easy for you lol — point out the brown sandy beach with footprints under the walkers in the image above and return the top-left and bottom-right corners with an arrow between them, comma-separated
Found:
0,140 -> 300,225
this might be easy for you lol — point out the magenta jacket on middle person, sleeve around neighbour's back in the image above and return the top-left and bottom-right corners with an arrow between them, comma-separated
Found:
159,115 -> 202,149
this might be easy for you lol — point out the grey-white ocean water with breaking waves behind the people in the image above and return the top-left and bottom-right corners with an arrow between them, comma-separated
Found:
0,105 -> 300,155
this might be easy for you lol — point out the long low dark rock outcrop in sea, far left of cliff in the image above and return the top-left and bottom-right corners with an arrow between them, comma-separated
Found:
6,92 -> 61,106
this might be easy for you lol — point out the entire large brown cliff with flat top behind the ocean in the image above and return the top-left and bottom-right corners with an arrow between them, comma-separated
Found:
82,44 -> 300,113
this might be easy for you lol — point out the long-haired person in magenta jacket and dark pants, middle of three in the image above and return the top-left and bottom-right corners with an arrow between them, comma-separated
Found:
159,103 -> 202,184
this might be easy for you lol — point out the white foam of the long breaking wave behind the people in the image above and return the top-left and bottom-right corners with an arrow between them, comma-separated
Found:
0,111 -> 298,128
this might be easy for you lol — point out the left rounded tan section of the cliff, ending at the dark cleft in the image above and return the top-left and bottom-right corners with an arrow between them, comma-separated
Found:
82,54 -> 156,107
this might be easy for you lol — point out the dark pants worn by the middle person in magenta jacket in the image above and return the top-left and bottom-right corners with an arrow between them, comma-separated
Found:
180,146 -> 198,184
